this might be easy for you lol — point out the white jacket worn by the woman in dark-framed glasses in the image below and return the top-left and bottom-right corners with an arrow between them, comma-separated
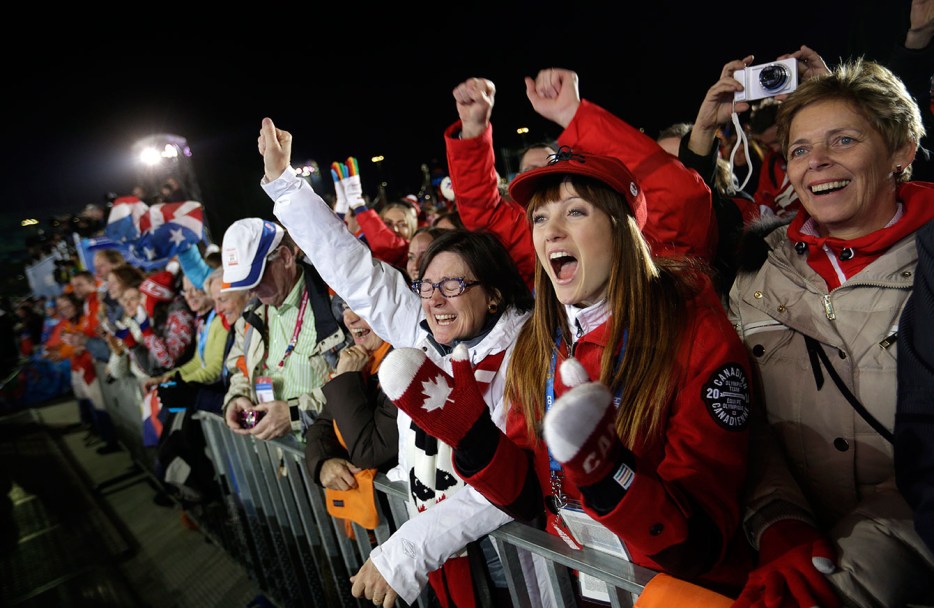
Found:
262,169 -> 529,604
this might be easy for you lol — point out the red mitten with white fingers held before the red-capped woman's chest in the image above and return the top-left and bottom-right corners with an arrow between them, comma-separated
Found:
544,358 -> 635,490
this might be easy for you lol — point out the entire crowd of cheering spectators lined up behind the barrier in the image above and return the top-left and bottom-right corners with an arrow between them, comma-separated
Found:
0,9 -> 934,608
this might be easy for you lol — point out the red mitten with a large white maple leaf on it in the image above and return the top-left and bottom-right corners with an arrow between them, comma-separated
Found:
379,344 -> 489,448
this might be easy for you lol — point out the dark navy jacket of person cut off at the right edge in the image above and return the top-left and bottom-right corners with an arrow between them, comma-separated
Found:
894,217 -> 934,551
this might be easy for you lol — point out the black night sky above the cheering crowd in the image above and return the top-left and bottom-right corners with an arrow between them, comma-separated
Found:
0,0 -> 910,268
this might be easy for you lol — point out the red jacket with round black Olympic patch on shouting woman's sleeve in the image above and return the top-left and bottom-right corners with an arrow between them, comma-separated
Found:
455,283 -> 753,593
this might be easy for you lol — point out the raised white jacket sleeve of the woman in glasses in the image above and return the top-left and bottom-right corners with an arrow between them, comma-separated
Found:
261,169 -> 423,348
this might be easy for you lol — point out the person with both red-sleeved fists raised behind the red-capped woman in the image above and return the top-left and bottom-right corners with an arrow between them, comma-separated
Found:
445,68 -> 716,292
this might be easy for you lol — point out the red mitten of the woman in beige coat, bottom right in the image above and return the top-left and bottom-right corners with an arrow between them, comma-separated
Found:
732,519 -> 841,608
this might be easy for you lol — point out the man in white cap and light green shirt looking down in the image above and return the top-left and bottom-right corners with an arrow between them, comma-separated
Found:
221,217 -> 345,439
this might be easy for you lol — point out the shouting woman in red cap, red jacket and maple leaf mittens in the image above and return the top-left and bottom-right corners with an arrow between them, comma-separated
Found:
380,141 -> 751,599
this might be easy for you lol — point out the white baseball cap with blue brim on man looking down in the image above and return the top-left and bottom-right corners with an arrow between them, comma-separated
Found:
221,217 -> 285,291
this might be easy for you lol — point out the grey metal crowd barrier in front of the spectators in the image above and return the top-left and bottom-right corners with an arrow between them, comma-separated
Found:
93,370 -> 656,608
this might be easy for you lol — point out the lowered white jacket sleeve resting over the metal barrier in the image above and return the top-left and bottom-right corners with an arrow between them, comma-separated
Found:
370,486 -> 512,604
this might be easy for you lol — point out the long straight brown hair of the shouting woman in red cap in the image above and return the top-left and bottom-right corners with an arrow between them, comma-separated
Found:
506,174 -> 696,447
